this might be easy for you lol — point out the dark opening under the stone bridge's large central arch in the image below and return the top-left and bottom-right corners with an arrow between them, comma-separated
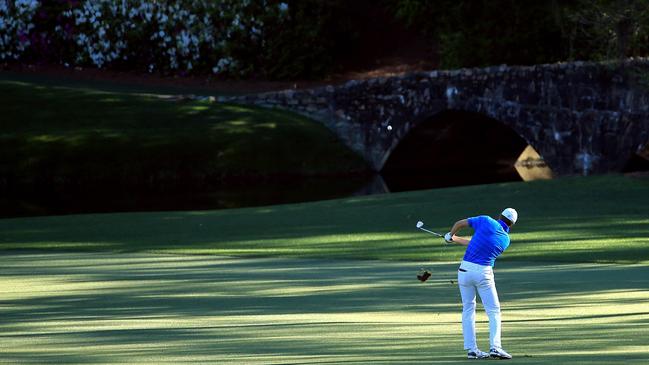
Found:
381,109 -> 549,191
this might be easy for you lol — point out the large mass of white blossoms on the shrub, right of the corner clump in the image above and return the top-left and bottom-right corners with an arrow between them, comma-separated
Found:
55,0 -> 286,74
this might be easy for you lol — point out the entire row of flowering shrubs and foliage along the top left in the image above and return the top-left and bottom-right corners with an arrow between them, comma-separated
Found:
0,0 -> 356,78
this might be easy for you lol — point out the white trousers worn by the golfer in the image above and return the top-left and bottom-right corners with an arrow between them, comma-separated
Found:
457,261 -> 501,350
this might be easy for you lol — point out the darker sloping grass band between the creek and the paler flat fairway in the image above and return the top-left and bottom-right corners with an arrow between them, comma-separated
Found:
0,175 -> 649,262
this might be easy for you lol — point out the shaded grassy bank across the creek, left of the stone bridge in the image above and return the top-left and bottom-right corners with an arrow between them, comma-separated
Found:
0,80 -> 365,191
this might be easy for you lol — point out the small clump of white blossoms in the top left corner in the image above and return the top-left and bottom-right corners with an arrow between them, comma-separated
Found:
0,0 -> 40,60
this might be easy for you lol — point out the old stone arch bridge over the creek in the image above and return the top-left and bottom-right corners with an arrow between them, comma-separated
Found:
224,59 -> 649,175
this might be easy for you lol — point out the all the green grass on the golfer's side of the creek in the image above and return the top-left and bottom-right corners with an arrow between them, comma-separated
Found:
0,175 -> 649,364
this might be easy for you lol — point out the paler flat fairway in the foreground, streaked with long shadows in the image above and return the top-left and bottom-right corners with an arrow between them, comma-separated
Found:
0,253 -> 649,364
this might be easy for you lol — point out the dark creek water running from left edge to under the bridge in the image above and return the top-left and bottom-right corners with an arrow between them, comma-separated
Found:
0,166 -> 532,218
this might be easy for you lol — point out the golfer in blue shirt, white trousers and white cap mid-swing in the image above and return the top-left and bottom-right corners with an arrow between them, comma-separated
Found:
444,208 -> 518,359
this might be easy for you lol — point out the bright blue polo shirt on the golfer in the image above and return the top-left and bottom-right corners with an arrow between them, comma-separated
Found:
464,215 -> 509,266
